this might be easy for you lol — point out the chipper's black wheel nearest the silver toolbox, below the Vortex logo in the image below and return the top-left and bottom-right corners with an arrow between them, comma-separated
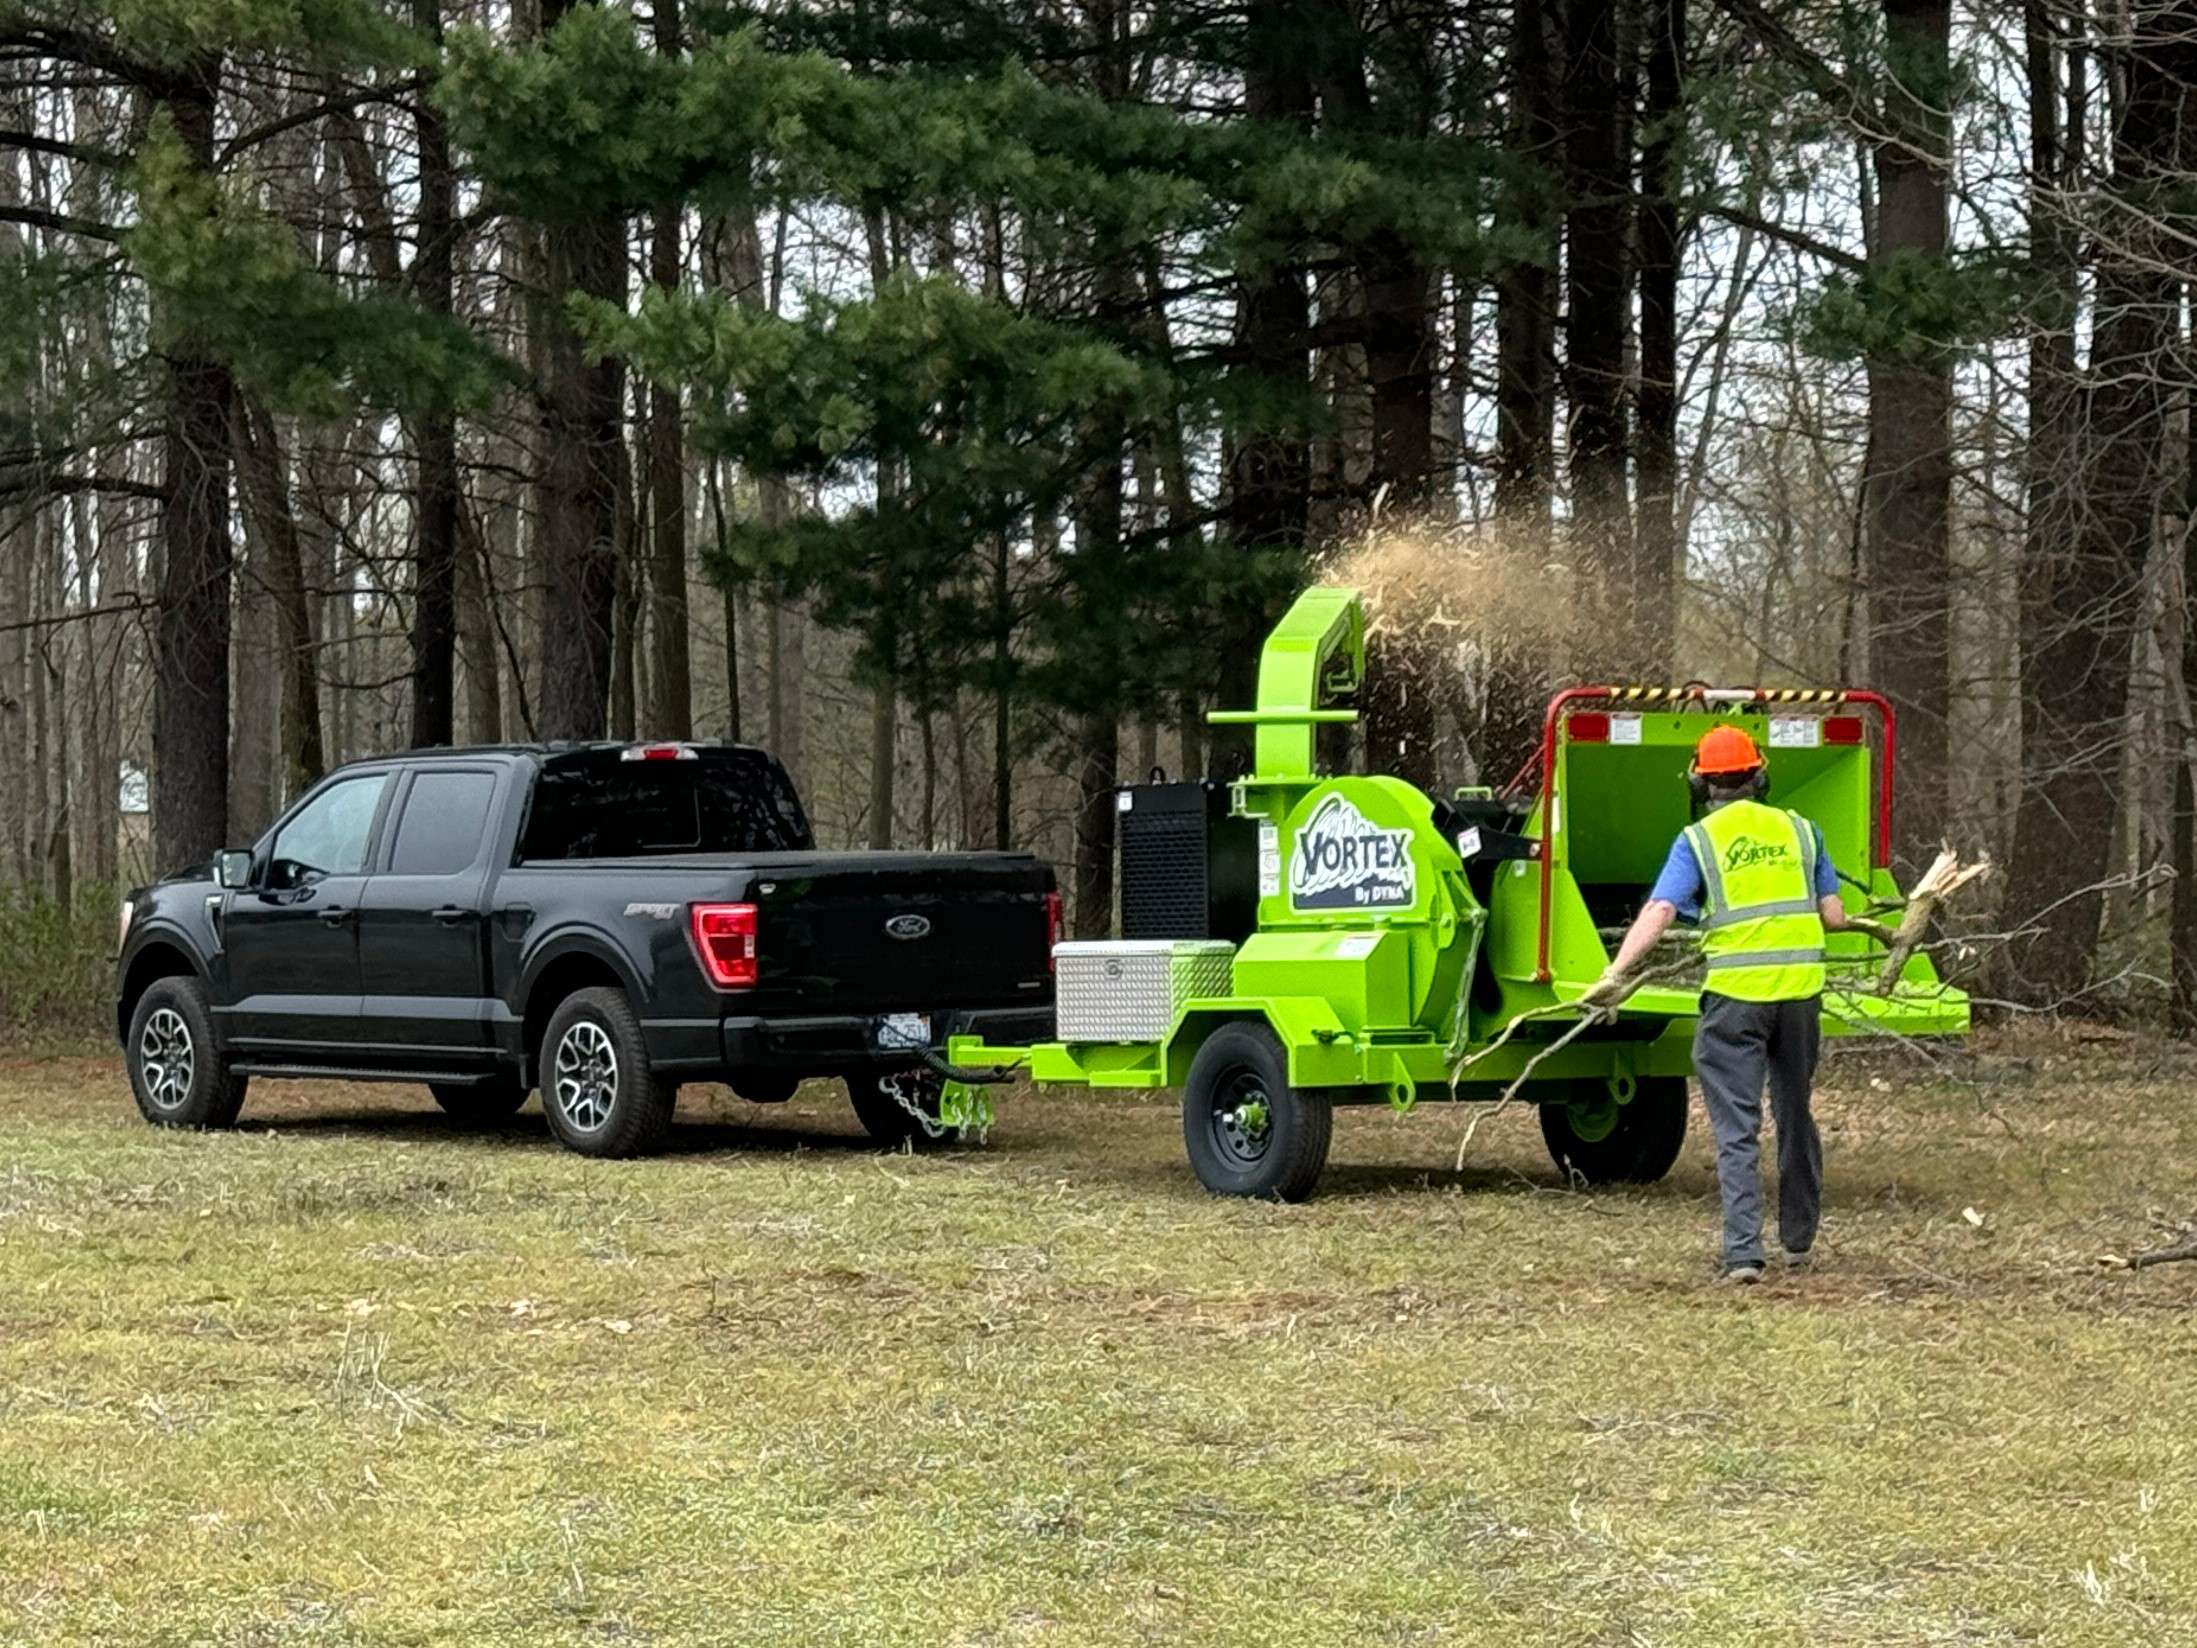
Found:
1182,1024 -> 1336,1202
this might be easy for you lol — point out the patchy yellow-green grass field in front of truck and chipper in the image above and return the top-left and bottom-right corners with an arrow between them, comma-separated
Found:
0,1039 -> 2197,1648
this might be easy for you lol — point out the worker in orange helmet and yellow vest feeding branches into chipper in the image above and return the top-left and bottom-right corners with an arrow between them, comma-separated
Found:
1584,727 -> 1889,1285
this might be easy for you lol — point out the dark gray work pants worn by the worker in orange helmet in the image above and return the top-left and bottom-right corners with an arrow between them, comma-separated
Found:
1694,991 -> 1824,1266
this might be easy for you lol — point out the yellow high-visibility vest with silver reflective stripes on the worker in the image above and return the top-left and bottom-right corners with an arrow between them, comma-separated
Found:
1685,802 -> 1824,1002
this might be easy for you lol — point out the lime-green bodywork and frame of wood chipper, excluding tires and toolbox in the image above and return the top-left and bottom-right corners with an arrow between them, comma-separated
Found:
947,587 -> 1969,1189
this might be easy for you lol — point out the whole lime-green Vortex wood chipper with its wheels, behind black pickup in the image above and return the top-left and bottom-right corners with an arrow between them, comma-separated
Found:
949,589 -> 1969,1200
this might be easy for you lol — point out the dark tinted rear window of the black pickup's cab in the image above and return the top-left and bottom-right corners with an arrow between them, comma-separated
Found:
518,749 -> 815,864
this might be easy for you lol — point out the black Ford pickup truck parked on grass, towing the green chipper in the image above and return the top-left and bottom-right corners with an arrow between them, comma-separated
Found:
114,745 -> 1059,1156
